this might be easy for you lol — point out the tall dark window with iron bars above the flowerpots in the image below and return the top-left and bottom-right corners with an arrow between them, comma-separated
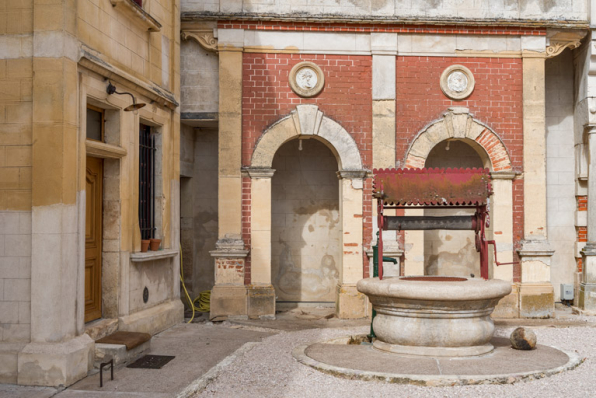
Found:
139,124 -> 156,239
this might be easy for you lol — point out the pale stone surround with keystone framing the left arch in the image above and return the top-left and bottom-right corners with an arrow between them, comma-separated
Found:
245,105 -> 368,318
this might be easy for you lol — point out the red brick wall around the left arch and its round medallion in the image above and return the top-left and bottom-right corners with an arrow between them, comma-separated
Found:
242,53 -> 372,284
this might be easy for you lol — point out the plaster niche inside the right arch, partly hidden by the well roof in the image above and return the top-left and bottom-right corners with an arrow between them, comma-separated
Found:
424,139 -> 484,277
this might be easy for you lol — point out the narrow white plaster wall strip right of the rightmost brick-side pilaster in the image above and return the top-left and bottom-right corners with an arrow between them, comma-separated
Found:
546,50 -> 577,301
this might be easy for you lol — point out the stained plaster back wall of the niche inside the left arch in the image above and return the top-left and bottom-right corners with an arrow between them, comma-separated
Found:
272,139 -> 342,302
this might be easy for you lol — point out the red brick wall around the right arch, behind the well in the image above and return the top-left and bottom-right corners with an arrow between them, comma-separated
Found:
396,57 -> 523,280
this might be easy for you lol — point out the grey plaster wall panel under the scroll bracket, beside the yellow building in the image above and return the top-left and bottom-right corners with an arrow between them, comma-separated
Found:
180,39 -> 219,113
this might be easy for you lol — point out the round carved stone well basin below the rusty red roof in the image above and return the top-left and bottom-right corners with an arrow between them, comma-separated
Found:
357,276 -> 511,357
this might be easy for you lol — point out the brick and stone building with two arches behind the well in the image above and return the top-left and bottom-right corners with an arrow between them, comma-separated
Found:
181,0 -> 596,324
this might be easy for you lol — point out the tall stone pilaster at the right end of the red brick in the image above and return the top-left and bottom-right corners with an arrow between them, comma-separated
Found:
518,45 -> 555,318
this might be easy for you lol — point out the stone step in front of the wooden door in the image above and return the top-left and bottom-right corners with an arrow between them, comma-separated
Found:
93,332 -> 151,369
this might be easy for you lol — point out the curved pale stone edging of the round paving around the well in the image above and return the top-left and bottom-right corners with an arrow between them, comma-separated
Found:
292,337 -> 586,387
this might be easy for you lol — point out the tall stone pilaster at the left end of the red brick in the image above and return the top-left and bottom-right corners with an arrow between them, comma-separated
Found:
210,29 -> 248,318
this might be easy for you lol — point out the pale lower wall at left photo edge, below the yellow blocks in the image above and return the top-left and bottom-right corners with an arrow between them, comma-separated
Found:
0,211 -> 31,343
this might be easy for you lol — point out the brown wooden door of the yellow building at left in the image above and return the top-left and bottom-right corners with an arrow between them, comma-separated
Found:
85,157 -> 103,322
